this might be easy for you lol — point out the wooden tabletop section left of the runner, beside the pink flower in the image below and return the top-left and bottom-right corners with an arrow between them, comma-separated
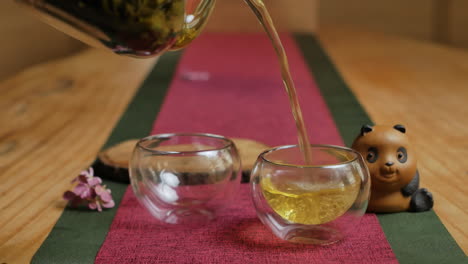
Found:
0,50 -> 154,264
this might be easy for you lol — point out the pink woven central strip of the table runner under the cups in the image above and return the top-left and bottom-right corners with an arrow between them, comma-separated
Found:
96,34 -> 397,263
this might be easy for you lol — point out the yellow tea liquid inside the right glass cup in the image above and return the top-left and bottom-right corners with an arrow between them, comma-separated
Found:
260,177 -> 361,225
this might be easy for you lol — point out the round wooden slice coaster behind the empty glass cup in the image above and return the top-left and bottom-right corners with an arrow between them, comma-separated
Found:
93,138 -> 269,183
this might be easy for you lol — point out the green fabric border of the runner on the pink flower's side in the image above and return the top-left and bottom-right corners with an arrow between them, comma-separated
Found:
32,52 -> 181,264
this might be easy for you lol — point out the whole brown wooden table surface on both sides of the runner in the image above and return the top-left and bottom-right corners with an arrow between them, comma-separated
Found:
0,27 -> 468,263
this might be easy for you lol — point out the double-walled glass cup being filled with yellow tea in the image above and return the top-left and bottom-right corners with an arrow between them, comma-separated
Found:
250,145 -> 370,244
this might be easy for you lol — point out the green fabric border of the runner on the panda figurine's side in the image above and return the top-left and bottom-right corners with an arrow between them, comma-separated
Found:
295,34 -> 468,264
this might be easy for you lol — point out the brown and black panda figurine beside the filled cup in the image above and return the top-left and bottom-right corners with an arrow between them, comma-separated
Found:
352,125 -> 434,213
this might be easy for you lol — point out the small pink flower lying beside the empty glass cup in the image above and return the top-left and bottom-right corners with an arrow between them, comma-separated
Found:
63,168 -> 115,212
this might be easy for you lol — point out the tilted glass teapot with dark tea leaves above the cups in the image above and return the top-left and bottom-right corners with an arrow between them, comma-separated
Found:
16,0 -> 216,58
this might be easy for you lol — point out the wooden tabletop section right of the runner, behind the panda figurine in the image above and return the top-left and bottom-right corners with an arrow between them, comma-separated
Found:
319,25 -> 468,254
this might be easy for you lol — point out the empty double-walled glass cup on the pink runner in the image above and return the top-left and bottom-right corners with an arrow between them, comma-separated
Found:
130,134 -> 241,225
